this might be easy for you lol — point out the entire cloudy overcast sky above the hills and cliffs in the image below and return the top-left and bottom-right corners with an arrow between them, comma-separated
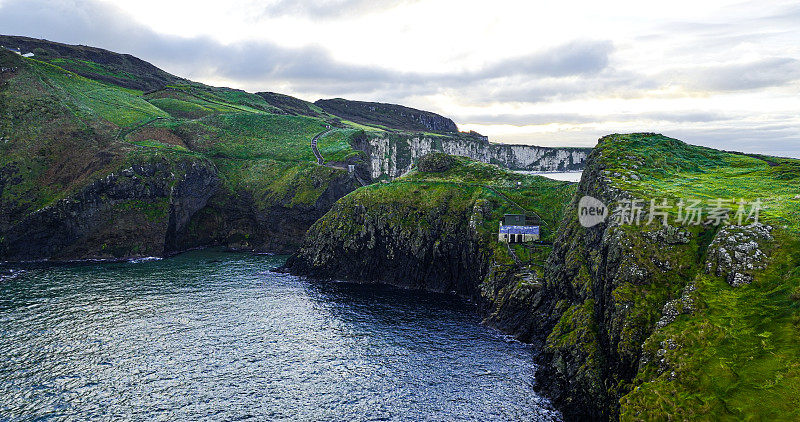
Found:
0,0 -> 800,157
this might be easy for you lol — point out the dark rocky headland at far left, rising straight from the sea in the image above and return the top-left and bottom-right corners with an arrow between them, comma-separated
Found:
0,159 -> 219,260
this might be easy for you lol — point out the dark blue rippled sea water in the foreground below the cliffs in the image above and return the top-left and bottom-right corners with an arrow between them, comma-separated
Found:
0,251 -> 558,421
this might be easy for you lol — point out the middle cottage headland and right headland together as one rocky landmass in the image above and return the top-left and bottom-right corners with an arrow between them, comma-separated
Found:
287,134 -> 800,420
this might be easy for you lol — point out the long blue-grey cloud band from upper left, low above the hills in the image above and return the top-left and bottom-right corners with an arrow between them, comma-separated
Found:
0,0 -> 613,100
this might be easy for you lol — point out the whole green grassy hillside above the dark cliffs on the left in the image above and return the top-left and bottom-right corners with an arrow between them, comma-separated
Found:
0,37 -> 374,258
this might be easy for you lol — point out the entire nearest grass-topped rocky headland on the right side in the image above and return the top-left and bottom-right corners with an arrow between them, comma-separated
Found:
537,134 -> 800,420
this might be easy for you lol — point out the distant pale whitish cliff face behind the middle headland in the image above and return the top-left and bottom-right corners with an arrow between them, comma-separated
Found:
356,134 -> 591,179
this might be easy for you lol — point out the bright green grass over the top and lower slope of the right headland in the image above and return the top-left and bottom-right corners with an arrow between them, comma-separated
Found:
580,134 -> 800,420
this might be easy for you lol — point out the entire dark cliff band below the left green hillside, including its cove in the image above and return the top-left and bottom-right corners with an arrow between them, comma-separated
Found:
0,152 -> 360,261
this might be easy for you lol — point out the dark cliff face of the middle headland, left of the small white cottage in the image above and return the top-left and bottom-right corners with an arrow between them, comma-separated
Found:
286,186 -> 487,297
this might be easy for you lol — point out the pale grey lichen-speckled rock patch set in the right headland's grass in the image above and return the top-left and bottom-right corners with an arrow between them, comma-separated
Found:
706,224 -> 774,287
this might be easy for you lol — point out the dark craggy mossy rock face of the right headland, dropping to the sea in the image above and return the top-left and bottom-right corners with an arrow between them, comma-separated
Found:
534,138 -> 714,420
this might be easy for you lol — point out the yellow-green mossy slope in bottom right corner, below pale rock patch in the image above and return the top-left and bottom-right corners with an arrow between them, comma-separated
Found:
622,234 -> 800,420
